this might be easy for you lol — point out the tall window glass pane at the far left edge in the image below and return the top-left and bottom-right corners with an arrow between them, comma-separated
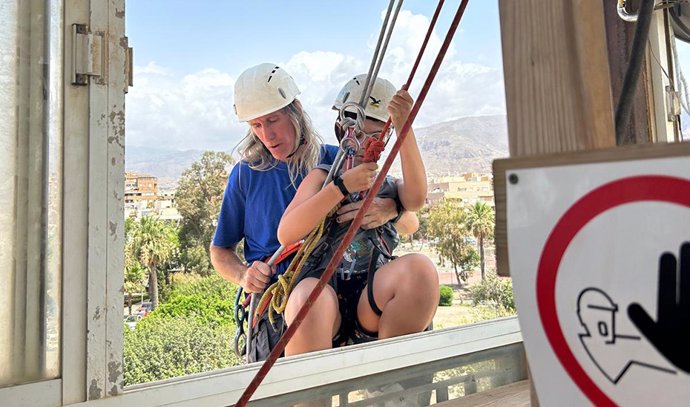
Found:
0,2 -> 62,386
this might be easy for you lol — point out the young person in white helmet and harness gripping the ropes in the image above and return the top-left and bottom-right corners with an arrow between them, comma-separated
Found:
278,75 -> 439,355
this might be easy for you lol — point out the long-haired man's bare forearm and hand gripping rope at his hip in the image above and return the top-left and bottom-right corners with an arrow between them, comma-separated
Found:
210,244 -> 272,293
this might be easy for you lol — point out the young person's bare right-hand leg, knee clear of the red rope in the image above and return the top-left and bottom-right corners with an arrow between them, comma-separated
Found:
357,253 -> 439,339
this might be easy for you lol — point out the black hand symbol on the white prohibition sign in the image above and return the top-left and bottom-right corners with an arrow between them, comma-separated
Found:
628,242 -> 690,373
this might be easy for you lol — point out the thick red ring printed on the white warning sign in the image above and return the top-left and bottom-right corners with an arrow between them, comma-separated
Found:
536,175 -> 690,407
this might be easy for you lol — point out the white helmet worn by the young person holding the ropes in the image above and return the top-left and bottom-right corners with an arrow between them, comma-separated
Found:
333,74 -> 397,122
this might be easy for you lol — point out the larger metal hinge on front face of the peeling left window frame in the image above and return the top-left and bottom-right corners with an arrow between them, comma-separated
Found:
72,24 -> 103,86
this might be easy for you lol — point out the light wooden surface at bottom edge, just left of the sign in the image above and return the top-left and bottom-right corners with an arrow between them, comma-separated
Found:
434,380 -> 530,407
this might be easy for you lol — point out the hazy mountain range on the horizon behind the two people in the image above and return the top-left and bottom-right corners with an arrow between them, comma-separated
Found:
125,115 -> 508,187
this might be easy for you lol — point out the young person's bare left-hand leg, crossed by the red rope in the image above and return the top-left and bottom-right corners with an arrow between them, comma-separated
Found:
285,278 -> 340,356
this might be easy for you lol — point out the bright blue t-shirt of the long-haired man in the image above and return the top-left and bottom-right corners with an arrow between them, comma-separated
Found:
213,145 -> 338,274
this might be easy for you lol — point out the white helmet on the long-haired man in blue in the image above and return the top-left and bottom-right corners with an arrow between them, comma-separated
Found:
235,63 -> 300,122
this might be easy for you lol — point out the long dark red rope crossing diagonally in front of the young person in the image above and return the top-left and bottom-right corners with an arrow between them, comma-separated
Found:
235,0 -> 469,407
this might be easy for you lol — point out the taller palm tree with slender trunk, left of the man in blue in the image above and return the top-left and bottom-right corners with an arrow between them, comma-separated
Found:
129,216 -> 179,309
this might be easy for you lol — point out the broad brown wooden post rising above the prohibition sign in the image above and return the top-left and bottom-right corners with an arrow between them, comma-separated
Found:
499,0 -> 615,157
